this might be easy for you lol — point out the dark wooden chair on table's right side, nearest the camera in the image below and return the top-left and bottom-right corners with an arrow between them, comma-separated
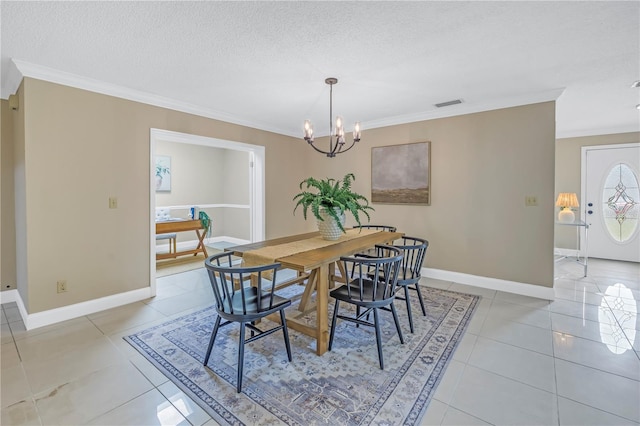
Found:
329,245 -> 404,370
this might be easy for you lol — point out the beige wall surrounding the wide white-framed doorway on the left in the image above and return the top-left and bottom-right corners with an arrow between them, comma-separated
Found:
12,78 -> 303,313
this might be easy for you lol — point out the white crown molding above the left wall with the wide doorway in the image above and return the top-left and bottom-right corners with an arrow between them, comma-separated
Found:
3,59 -> 288,135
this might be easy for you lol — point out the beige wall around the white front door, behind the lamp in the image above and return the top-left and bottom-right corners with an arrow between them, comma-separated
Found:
555,132 -> 640,249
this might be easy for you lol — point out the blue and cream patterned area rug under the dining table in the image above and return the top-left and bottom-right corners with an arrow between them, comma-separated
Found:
124,286 -> 479,426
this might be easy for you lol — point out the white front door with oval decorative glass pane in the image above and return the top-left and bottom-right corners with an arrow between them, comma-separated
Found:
581,144 -> 640,262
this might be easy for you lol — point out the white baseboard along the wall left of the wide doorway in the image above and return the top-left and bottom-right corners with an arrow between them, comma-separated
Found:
0,287 -> 154,330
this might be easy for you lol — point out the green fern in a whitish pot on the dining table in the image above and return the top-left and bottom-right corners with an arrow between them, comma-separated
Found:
293,173 -> 374,240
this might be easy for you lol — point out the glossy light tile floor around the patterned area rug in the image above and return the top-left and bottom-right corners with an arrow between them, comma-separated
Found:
0,259 -> 640,425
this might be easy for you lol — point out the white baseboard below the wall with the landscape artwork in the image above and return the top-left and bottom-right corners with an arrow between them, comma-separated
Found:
421,268 -> 555,300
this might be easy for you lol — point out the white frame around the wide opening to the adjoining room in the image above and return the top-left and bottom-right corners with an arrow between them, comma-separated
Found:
149,128 -> 265,295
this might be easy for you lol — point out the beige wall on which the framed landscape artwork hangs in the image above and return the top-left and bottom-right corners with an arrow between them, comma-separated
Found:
297,102 -> 555,287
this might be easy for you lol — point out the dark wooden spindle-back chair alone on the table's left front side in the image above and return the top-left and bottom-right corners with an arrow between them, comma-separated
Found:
203,252 -> 291,393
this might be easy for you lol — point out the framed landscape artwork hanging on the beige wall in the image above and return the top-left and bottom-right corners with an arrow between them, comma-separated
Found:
371,142 -> 431,206
